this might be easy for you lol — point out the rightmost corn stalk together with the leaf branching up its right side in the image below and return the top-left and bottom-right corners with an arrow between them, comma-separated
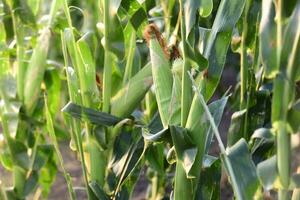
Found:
272,0 -> 300,200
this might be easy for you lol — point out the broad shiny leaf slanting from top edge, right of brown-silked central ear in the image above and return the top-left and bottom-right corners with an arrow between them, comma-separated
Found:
200,0 -> 246,99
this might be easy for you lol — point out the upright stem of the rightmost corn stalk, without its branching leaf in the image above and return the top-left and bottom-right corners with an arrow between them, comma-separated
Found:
272,0 -> 291,196
